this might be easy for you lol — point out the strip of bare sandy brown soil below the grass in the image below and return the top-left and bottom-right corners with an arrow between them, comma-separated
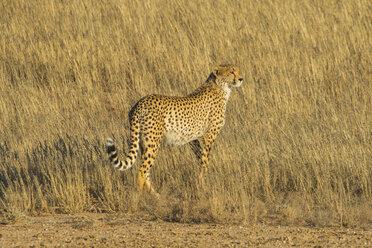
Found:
0,214 -> 372,247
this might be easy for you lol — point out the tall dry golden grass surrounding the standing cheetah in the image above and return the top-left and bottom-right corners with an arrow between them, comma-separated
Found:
0,0 -> 372,226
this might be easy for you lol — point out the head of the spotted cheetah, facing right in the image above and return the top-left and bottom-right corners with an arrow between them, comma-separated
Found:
209,65 -> 243,87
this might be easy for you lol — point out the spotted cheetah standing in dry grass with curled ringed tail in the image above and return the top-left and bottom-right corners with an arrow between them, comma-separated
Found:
107,65 -> 243,196
